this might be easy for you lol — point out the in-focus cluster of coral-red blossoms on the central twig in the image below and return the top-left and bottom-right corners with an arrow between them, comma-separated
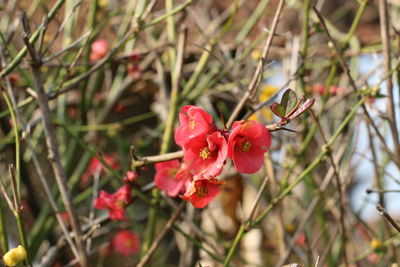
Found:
155,105 -> 271,208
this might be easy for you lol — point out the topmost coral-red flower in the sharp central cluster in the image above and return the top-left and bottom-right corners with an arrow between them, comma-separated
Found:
175,105 -> 216,147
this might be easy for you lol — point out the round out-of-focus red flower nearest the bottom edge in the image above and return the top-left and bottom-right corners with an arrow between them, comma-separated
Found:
111,230 -> 139,257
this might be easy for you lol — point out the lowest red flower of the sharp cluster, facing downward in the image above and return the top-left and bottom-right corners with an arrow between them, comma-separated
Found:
181,179 -> 224,209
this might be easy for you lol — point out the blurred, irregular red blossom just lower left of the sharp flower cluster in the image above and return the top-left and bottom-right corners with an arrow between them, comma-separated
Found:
94,184 -> 132,220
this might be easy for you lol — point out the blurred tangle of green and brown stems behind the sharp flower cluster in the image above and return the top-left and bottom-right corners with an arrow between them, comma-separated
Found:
0,0 -> 400,267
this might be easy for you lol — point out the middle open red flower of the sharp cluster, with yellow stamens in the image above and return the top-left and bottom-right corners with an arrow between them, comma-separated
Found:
183,131 -> 228,178
